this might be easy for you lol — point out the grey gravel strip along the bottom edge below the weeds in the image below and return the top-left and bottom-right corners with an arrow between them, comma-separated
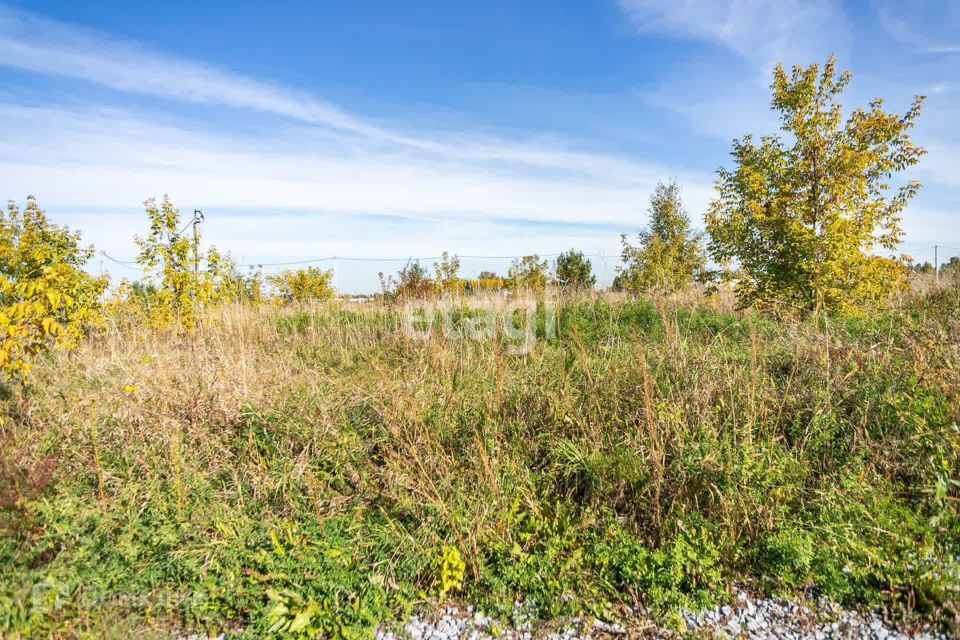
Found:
375,592 -> 949,640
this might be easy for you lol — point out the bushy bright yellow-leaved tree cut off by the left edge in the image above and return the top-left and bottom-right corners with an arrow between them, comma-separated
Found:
0,196 -> 107,379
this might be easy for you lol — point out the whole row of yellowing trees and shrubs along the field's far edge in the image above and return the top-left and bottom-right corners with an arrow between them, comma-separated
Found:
0,56 -> 936,375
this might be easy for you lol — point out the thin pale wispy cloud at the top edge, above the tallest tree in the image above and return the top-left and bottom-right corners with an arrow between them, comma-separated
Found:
618,0 -> 851,145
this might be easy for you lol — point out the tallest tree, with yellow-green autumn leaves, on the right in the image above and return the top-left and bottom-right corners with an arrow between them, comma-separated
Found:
706,56 -> 924,315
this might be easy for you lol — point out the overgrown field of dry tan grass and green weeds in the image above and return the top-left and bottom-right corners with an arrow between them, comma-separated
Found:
0,288 -> 960,637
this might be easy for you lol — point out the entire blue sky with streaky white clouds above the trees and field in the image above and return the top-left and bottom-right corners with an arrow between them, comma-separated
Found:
0,0 -> 960,291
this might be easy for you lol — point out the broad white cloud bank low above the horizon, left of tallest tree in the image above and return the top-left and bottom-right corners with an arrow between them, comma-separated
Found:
0,97 -> 676,292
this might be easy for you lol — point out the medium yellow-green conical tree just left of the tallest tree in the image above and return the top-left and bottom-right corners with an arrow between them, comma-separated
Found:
616,180 -> 706,294
